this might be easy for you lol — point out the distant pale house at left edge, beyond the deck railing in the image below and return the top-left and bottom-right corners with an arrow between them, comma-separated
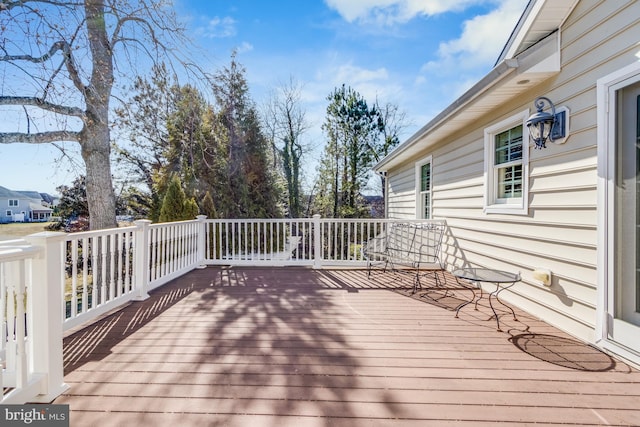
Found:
0,187 -> 53,223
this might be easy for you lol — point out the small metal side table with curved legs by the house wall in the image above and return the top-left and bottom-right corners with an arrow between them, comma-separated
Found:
452,268 -> 520,332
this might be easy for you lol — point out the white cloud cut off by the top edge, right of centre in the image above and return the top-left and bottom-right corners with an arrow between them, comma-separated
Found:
325,0 -> 486,25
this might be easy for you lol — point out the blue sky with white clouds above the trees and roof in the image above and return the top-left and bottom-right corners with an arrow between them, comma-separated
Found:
0,0 -> 527,194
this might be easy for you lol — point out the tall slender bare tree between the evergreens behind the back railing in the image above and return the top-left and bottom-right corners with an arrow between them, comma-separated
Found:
263,78 -> 309,218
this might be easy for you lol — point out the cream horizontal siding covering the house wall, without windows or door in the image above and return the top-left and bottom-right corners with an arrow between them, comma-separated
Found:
388,1 -> 640,341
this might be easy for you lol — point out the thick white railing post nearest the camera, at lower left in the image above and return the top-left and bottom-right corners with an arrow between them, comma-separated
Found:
26,232 -> 69,403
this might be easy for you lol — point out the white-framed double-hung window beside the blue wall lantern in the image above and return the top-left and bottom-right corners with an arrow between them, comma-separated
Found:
484,110 -> 529,215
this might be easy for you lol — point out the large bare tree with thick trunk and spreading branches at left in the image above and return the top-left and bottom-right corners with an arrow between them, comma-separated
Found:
0,0 -> 194,229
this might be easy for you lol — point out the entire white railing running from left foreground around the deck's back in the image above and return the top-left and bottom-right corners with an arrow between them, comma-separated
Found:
0,216 -> 444,404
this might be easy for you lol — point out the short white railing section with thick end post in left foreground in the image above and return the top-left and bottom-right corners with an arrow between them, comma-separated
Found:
0,235 -> 68,404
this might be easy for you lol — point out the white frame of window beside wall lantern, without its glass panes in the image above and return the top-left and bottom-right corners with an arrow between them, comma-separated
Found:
484,109 -> 531,215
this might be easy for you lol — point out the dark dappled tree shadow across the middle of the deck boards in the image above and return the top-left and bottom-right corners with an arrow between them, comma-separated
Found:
188,268 -> 400,426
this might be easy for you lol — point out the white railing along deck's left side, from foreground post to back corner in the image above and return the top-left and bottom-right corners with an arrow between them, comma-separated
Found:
61,217 -> 204,330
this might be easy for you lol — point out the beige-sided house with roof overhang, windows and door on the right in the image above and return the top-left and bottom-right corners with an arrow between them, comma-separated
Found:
375,0 -> 640,364
